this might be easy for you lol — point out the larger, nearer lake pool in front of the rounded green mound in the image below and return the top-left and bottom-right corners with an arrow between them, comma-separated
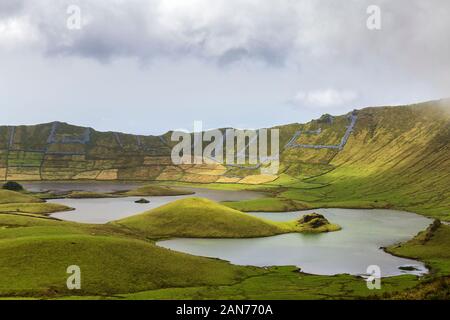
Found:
157,209 -> 431,276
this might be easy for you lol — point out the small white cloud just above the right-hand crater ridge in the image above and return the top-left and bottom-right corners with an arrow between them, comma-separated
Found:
292,89 -> 358,109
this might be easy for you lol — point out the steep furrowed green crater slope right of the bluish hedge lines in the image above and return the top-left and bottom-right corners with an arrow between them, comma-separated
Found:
285,102 -> 450,220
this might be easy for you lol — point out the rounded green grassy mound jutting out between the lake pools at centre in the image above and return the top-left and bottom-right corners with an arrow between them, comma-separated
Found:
113,198 -> 339,238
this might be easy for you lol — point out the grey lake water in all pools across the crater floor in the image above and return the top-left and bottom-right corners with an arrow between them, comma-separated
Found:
27,182 -> 432,276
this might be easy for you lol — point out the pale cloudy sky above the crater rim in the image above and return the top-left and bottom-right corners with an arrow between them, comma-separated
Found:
0,0 -> 450,134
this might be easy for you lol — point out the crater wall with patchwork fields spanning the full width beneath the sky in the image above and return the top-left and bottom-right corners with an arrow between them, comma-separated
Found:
0,100 -> 450,196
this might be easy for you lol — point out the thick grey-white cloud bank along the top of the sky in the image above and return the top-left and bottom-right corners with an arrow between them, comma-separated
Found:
0,0 -> 450,70
